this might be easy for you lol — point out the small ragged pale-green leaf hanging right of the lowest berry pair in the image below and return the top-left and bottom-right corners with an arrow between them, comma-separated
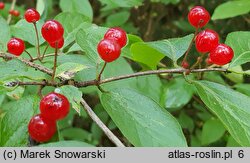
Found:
57,85 -> 82,114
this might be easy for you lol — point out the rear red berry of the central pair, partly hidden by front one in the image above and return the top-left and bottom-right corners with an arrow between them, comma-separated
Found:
104,27 -> 127,48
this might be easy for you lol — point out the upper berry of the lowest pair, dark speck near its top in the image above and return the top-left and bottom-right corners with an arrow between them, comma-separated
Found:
40,92 -> 70,120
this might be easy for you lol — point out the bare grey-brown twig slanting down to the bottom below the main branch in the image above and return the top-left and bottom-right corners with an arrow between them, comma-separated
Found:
81,99 -> 125,147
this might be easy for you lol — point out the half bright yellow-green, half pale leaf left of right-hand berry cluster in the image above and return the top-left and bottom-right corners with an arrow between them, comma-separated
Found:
130,34 -> 193,69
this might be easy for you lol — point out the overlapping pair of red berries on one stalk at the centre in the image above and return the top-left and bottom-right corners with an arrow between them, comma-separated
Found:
97,27 -> 127,62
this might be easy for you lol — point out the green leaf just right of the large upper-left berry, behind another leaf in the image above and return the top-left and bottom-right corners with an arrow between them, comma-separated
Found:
55,12 -> 91,47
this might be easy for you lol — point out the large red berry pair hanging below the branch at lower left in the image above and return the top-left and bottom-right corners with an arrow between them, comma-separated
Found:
28,92 -> 70,142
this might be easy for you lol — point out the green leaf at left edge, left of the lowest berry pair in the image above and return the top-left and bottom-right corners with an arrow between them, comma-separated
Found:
0,96 -> 39,147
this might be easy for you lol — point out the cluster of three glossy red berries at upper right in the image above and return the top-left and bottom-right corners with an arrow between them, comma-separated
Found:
188,6 -> 234,65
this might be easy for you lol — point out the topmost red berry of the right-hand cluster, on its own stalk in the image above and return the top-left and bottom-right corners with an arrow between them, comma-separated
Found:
188,6 -> 210,28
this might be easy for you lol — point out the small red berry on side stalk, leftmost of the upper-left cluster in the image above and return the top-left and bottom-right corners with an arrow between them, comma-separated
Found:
7,38 -> 25,56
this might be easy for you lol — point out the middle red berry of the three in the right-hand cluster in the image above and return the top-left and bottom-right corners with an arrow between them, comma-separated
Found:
195,29 -> 219,53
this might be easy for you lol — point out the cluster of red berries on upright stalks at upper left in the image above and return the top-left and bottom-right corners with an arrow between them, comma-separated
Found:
7,9 -> 64,56
